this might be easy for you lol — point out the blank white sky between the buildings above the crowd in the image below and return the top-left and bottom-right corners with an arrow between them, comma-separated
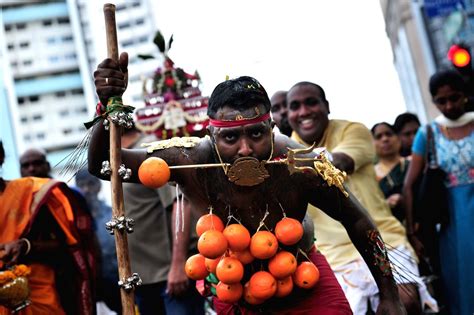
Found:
153,0 -> 406,128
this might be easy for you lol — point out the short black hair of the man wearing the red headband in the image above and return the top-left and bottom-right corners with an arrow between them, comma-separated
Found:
207,76 -> 271,118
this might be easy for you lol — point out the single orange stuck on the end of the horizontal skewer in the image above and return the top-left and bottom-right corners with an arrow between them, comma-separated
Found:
138,157 -> 171,188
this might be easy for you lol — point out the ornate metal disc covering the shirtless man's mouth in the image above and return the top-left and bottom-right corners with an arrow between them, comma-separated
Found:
227,157 -> 270,186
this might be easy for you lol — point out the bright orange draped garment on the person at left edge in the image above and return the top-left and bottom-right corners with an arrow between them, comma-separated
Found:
0,177 -> 78,315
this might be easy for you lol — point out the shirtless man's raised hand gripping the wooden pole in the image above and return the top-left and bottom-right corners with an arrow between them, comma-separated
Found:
94,52 -> 128,106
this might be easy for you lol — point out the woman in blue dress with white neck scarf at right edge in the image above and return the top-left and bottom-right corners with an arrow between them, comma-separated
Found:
403,70 -> 474,315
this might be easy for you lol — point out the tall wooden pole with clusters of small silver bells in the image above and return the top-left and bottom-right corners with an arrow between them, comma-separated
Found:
104,3 -> 135,315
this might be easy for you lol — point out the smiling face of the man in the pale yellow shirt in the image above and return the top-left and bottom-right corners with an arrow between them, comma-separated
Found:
287,85 -> 329,143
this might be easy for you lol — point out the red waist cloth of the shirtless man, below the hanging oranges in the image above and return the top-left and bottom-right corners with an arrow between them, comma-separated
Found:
213,251 -> 352,315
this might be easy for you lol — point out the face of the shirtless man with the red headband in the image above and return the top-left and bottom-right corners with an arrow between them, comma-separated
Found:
210,106 -> 273,163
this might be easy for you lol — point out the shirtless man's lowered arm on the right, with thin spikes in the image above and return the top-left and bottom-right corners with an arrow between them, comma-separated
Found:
309,186 -> 405,314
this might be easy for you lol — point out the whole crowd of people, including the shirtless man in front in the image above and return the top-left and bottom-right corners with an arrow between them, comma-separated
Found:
0,49 -> 474,315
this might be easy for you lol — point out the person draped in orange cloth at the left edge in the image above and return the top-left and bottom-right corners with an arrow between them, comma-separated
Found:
0,142 -> 95,315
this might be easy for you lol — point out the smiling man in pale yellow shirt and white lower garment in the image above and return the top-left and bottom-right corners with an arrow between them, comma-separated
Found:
287,82 -> 437,314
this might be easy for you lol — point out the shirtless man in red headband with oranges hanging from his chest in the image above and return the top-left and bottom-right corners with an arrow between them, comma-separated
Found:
89,54 -> 405,314
